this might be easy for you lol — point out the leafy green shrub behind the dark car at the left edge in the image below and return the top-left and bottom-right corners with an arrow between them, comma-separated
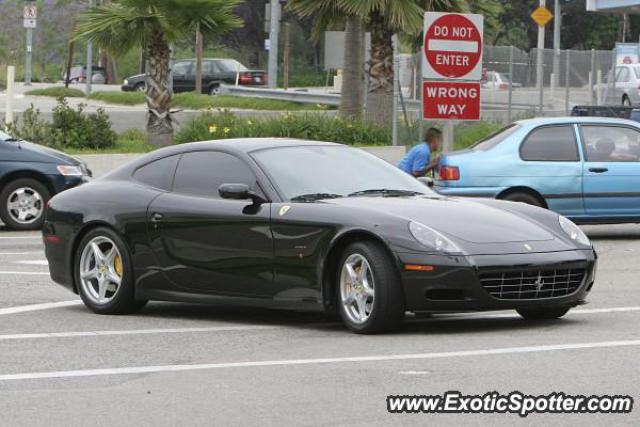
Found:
9,98 -> 117,149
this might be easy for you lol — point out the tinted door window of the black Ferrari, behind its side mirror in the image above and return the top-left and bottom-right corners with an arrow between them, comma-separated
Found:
173,151 -> 261,198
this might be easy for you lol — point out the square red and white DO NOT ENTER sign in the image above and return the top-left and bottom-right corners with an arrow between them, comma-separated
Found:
422,12 -> 484,80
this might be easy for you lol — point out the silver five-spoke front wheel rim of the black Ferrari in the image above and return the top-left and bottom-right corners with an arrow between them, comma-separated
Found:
340,253 -> 375,324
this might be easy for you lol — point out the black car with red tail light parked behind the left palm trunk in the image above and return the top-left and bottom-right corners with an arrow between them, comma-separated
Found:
122,58 -> 267,95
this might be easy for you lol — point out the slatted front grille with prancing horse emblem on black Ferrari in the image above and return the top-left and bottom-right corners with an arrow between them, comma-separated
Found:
480,268 -> 586,300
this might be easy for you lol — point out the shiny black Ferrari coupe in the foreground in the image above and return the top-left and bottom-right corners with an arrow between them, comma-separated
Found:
43,139 -> 596,333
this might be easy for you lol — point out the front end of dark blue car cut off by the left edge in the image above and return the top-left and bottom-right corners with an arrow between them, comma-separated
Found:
0,131 -> 91,230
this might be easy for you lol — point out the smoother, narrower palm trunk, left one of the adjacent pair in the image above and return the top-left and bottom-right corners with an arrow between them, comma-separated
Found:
339,16 -> 364,120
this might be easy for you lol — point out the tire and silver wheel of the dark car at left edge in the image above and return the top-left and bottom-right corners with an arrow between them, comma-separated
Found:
0,178 -> 51,230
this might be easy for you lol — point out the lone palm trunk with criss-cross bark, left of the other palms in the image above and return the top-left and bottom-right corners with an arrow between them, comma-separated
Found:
145,31 -> 173,145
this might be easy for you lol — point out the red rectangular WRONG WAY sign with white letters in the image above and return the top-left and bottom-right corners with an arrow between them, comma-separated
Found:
422,81 -> 480,120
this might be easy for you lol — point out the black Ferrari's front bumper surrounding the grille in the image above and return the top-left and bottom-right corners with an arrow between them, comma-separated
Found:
398,250 -> 597,312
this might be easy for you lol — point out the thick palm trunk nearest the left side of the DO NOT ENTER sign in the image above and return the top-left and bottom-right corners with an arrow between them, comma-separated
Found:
365,11 -> 393,127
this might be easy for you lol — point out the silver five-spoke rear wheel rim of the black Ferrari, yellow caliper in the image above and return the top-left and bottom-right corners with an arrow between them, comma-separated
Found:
80,236 -> 123,304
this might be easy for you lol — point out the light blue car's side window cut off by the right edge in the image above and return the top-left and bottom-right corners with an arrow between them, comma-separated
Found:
581,125 -> 640,162
